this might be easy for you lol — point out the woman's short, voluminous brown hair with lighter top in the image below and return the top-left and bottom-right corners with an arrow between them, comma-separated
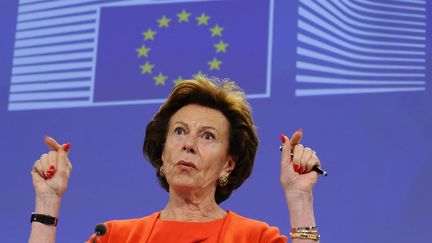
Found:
143,76 -> 258,204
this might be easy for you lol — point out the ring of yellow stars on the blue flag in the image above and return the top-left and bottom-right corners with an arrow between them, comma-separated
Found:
135,9 -> 229,86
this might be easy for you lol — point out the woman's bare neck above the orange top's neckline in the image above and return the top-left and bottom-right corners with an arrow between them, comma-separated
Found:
160,188 -> 226,222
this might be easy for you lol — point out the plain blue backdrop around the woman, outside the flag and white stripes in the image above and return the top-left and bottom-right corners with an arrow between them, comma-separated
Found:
0,0 -> 432,243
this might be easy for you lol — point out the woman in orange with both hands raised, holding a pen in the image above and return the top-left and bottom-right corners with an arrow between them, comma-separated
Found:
29,77 -> 320,243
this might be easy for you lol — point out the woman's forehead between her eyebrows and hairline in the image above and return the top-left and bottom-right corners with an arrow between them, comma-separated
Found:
170,104 -> 229,131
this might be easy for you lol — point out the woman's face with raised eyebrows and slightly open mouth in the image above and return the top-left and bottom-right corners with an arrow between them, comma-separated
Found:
162,104 -> 235,194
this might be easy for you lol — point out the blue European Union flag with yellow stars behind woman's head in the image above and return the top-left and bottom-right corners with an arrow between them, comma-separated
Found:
94,1 -> 270,102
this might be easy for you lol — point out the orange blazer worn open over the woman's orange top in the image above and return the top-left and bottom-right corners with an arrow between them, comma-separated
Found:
88,211 -> 287,243
